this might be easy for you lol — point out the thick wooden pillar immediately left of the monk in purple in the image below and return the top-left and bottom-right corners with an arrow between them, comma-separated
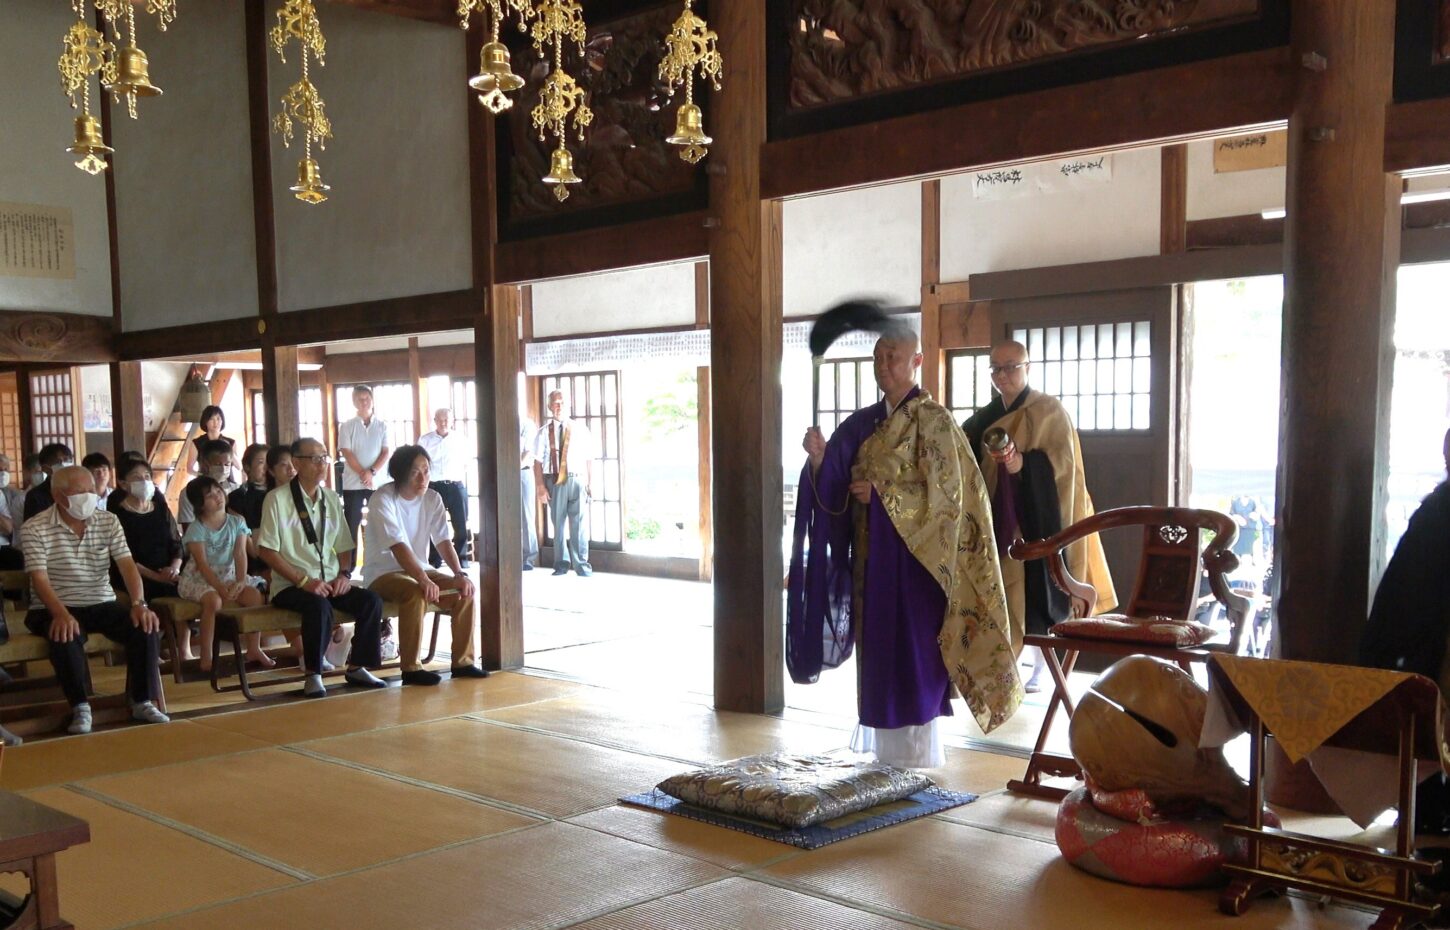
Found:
706,3 -> 784,712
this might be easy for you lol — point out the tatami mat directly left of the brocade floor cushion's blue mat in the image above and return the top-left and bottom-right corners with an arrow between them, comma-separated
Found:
307,718 -> 682,817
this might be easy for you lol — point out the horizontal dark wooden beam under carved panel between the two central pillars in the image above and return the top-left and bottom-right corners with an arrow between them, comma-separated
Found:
499,212 -> 709,284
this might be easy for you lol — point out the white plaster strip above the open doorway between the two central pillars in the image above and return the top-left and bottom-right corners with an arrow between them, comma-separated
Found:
534,261 -> 695,338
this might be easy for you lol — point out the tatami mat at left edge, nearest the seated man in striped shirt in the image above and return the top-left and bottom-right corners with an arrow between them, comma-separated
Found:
0,721 -> 267,791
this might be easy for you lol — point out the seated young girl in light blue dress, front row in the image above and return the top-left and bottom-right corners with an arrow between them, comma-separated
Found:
177,476 -> 277,672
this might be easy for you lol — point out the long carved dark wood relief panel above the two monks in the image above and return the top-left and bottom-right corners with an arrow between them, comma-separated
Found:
789,0 -> 1264,109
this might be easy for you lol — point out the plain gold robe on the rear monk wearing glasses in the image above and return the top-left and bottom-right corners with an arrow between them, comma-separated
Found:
982,390 -> 1118,650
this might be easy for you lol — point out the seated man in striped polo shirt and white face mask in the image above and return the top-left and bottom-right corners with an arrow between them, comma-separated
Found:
20,466 -> 171,733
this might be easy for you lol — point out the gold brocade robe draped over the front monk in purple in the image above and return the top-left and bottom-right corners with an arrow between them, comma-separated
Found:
853,392 -> 1022,733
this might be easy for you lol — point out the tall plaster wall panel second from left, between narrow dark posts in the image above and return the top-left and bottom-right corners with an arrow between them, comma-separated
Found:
112,0 -> 257,331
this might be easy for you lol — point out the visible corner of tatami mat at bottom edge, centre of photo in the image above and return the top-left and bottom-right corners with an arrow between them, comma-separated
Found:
574,878 -> 914,930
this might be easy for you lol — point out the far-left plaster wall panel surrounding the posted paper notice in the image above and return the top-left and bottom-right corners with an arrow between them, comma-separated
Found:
0,0 -> 112,316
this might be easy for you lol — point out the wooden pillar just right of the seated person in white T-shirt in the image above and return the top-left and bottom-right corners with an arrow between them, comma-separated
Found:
460,29 -> 523,669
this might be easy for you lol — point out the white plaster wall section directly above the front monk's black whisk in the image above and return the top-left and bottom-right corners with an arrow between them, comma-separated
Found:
782,181 -> 921,318
